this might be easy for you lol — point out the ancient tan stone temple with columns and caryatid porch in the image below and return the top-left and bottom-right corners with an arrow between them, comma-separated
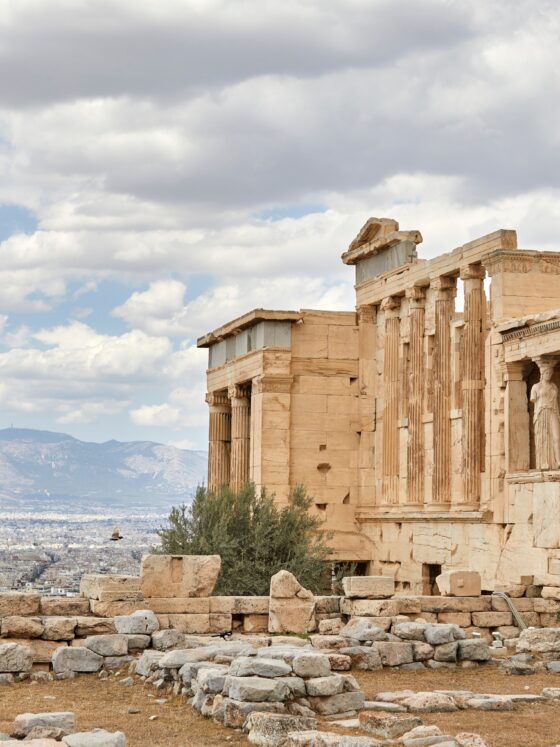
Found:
198,218 -> 560,593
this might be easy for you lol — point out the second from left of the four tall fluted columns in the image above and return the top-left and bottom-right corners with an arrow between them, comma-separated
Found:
406,288 -> 426,504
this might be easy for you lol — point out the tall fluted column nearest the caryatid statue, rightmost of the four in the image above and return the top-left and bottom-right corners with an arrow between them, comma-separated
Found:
461,265 -> 485,505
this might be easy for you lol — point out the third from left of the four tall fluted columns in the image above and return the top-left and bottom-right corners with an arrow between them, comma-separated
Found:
430,276 -> 456,503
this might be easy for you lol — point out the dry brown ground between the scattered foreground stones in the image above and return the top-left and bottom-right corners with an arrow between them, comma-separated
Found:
0,667 -> 560,747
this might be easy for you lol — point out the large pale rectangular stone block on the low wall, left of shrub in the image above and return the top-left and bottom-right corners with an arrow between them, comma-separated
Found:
140,555 -> 221,599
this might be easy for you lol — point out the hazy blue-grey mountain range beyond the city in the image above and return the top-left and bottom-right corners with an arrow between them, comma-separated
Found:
0,428 -> 207,508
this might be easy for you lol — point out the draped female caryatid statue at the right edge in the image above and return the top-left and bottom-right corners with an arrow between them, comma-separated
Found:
531,360 -> 560,469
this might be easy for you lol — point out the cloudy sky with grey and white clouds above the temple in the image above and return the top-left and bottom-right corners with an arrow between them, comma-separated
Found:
0,0 -> 560,448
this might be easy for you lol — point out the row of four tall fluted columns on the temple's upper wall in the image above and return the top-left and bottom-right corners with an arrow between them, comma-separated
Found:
374,265 -> 485,505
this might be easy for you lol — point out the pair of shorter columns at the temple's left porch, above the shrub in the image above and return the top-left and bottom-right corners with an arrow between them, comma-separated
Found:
206,384 -> 251,490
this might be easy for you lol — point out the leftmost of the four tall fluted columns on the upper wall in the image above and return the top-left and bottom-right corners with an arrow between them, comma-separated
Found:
381,296 -> 401,503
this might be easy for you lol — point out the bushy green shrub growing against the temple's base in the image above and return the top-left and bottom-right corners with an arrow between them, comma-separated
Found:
154,483 -> 330,596
